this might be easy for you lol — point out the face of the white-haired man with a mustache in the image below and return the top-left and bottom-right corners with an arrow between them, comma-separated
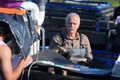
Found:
65,16 -> 80,33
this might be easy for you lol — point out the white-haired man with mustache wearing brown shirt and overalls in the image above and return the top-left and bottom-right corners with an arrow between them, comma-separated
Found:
49,13 -> 93,64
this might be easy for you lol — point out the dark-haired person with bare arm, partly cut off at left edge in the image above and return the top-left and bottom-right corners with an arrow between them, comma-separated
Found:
0,21 -> 32,80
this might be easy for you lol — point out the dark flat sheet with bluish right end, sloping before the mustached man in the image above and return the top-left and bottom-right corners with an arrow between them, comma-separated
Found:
32,49 -> 112,78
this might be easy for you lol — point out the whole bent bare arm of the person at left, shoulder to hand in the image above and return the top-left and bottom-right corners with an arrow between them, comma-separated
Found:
0,46 -> 32,80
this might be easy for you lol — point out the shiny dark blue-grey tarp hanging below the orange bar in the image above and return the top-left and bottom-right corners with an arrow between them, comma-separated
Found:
0,13 -> 37,58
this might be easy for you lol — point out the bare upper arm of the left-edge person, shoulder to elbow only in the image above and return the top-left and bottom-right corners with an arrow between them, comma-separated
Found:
0,45 -> 12,80
